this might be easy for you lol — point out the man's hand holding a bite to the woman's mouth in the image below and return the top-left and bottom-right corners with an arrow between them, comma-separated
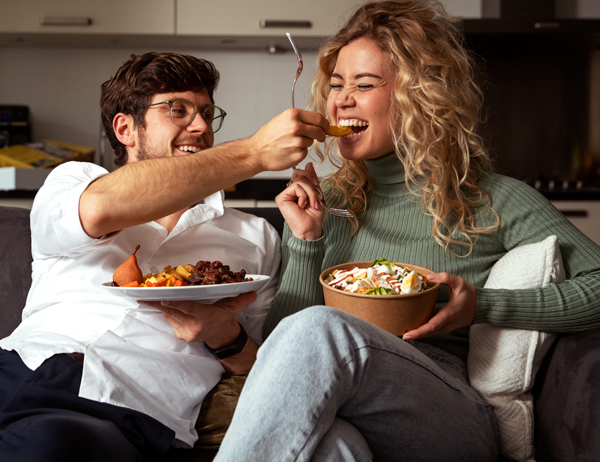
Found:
248,109 -> 329,171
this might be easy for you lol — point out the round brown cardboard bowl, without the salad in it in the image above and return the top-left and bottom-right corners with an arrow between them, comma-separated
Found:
319,260 -> 440,336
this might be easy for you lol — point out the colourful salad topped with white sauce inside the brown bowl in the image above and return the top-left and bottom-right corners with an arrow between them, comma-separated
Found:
325,258 -> 433,295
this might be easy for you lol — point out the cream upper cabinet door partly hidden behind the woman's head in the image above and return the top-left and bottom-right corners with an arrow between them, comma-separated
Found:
176,0 -> 481,37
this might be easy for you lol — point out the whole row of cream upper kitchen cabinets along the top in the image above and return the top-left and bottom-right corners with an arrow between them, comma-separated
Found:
0,0 -> 481,47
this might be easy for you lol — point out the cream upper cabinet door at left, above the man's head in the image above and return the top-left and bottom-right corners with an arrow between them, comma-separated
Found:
0,0 -> 175,35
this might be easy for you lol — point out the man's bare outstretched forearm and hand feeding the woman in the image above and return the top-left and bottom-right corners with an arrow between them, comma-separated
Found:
79,109 -> 329,238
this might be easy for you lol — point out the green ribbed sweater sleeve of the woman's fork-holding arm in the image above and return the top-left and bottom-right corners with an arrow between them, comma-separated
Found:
263,224 -> 325,339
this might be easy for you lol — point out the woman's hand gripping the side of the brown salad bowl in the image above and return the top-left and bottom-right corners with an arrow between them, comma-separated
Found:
402,273 -> 477,340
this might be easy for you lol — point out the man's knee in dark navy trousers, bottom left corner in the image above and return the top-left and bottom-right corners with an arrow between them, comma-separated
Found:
0,414 -> 142,462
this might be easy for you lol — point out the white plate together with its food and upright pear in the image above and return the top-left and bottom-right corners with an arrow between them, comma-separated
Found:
102,245 -> 270,301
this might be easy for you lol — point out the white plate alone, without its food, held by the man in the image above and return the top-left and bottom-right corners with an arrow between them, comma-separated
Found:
102,274 -> 271,301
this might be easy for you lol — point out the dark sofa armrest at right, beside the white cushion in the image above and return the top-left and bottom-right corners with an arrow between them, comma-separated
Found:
533,328 -> 600,462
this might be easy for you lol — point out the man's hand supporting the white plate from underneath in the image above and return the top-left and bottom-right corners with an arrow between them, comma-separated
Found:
140,292 -> 256,348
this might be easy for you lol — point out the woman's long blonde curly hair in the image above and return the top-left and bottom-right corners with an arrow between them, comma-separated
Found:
309,0 -> 500,255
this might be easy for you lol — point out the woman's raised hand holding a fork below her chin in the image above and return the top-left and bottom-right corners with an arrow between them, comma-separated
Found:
275,162 -> 326,241
